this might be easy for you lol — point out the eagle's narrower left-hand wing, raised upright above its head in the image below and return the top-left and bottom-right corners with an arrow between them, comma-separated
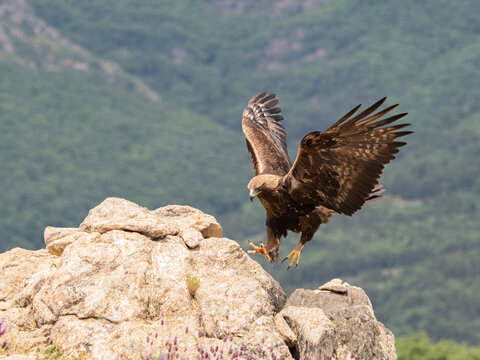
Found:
242,92 -> 292,176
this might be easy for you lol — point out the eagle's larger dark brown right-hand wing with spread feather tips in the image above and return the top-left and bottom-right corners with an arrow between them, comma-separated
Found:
285,98 -> 411,215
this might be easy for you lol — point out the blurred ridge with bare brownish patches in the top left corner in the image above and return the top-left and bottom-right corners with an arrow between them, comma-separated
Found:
0,0 -> 160,101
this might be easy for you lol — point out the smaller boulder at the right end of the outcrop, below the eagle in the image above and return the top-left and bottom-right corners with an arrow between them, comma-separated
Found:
279,279 -> 396,359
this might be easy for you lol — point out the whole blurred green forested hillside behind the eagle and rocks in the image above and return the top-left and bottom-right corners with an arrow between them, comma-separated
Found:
0,0 -> 480,344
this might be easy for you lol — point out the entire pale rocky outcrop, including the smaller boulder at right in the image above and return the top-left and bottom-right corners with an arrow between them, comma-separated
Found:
0,198 -> 396,359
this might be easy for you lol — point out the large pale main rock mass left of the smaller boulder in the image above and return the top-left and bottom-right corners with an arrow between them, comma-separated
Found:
0,198 -> 291,359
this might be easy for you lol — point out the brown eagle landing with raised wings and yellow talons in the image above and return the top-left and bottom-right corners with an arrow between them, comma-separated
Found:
242,92 -> 412,269
